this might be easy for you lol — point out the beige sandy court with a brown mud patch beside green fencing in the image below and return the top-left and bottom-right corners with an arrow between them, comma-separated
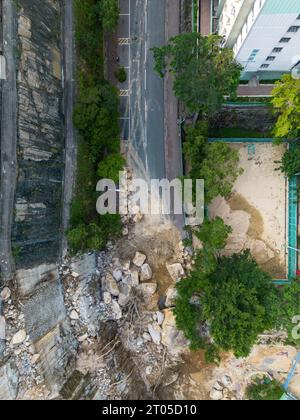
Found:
210,143 -> 287,279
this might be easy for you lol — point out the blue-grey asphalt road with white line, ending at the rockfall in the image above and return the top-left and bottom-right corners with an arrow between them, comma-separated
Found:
130,0 -> 166,179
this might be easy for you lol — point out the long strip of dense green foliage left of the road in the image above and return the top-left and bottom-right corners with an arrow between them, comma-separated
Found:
68,0 -> 124,253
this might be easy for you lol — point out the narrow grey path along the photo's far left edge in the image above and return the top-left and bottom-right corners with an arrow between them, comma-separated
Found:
0,0 -> 17,281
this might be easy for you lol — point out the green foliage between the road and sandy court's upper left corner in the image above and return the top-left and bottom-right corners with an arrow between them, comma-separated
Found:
184,122 -> 242,204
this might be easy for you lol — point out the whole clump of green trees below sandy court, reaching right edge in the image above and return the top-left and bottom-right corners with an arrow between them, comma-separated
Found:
174,218 -> 300,362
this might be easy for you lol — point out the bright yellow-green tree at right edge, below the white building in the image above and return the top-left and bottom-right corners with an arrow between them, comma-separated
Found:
272,75 -> 300,139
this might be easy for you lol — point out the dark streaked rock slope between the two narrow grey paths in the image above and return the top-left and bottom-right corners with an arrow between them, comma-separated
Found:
13,0 -> 64,268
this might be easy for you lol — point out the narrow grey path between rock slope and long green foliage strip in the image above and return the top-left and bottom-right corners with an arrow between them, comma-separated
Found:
62,0 -> 77,253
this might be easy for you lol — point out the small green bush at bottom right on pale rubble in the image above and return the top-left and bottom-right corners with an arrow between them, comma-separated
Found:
246,377 -> 284,401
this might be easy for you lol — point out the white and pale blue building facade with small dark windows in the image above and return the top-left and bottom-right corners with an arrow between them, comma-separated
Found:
218,0 -> 300,80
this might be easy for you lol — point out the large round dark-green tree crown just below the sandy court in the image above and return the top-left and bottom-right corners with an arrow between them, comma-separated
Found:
201,251 -> 280,357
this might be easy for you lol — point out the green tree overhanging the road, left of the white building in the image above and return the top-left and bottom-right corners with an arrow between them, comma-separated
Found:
153,33 -> 242,114
